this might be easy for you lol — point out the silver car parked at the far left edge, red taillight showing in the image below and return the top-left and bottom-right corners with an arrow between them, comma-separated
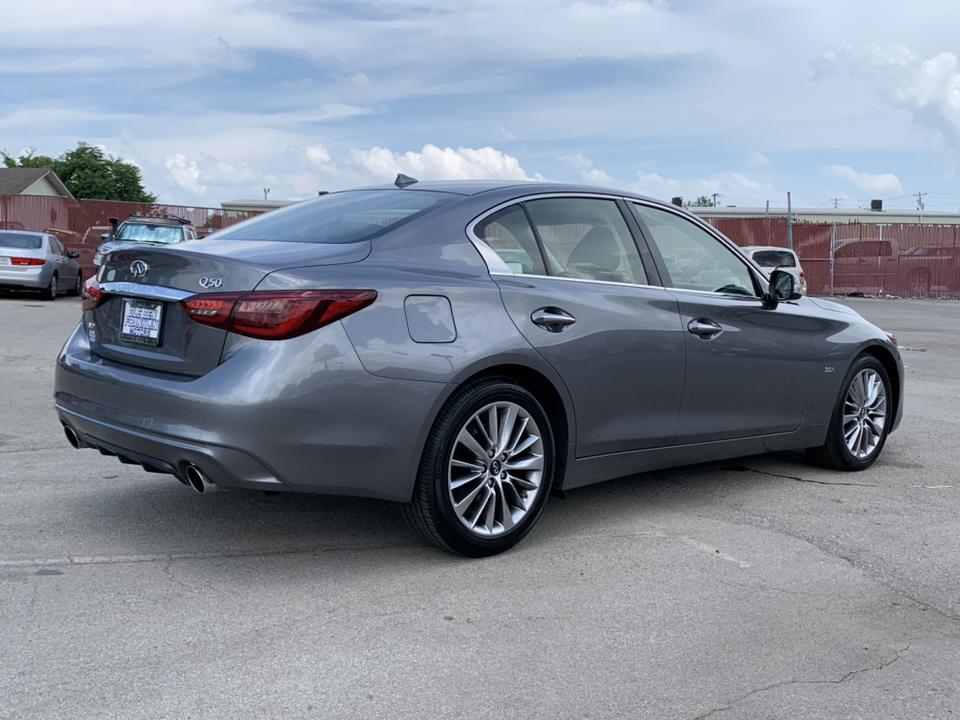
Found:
0,230 -> 83,300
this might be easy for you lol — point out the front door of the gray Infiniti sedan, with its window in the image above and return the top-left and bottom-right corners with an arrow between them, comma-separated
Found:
630,202 -> 819,443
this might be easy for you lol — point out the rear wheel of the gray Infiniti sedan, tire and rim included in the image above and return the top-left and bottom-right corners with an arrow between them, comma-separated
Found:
404,378 -> 556,557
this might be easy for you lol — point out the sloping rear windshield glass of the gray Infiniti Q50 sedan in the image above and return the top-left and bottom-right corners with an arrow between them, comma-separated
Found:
216,190 -> 456,244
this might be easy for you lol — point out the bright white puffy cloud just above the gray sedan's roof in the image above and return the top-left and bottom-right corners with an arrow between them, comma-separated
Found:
350,144 -> 540,180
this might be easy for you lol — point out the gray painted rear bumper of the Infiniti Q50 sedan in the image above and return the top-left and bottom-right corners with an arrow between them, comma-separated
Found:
54,323 -> 446,501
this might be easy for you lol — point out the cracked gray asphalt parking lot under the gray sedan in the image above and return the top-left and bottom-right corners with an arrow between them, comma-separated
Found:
0,296 -> 960,720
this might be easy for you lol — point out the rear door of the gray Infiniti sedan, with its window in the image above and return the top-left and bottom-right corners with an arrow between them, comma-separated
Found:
471,196 -> 684,457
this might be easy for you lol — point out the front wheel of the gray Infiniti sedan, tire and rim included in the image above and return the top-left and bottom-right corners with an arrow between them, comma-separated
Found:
810,355 -> 892,470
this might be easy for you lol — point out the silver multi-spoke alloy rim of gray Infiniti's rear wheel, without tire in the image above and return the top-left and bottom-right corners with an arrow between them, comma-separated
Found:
447,401 -> 543,537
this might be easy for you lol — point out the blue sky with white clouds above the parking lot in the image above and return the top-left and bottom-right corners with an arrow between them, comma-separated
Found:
0,0 -> 960,211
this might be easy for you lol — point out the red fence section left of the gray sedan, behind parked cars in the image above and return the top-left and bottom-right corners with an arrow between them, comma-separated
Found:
0,195 -> 257,277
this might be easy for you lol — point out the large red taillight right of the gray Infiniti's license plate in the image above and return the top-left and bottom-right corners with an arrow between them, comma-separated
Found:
181,290 -> 377,340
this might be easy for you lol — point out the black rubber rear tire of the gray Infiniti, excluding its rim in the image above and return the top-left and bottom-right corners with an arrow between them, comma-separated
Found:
403,377 -> 556,557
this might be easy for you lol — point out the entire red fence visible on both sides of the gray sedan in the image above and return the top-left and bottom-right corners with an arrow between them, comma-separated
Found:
0,195 -> 960,298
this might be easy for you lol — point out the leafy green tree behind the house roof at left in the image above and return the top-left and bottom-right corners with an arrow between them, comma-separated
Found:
3,142 -> 157,203
